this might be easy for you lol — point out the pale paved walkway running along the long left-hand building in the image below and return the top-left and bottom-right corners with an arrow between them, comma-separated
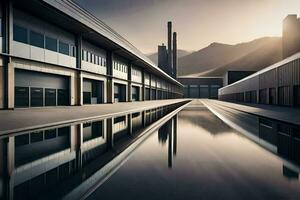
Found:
0,99 -> 188,136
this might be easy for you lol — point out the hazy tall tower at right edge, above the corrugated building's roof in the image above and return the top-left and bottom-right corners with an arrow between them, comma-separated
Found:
282,15 -> 300,59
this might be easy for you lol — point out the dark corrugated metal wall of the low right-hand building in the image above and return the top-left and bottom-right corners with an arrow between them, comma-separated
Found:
219,54 -> 300,106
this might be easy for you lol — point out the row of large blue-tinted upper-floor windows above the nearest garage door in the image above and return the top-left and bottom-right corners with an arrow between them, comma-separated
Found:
13,24 -> 76,57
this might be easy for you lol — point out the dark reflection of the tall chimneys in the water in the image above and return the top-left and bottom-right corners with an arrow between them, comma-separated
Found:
158,115 -> 177,168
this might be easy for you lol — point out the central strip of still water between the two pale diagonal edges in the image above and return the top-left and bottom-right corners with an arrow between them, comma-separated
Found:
89,105 -> 300,200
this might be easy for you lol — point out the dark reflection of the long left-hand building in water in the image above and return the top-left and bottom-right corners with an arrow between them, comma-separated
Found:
0,105 -> 183,200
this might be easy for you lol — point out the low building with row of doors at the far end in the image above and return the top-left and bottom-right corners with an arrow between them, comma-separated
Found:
177,76 -> 223,99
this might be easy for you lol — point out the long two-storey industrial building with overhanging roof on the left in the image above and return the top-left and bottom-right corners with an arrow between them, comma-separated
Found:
0,0 -> 182,109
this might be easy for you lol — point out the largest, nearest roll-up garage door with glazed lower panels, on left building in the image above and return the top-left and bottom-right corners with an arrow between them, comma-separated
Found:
15,69 -> 69,107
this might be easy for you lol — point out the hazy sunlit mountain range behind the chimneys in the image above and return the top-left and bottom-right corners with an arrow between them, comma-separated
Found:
149,37 -> 282,77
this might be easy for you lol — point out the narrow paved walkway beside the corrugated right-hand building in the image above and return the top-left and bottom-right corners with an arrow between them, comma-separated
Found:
202,99 -> 300,125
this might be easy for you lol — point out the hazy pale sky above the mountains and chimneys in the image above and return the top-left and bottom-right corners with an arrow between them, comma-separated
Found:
75,0 -> 300,53
